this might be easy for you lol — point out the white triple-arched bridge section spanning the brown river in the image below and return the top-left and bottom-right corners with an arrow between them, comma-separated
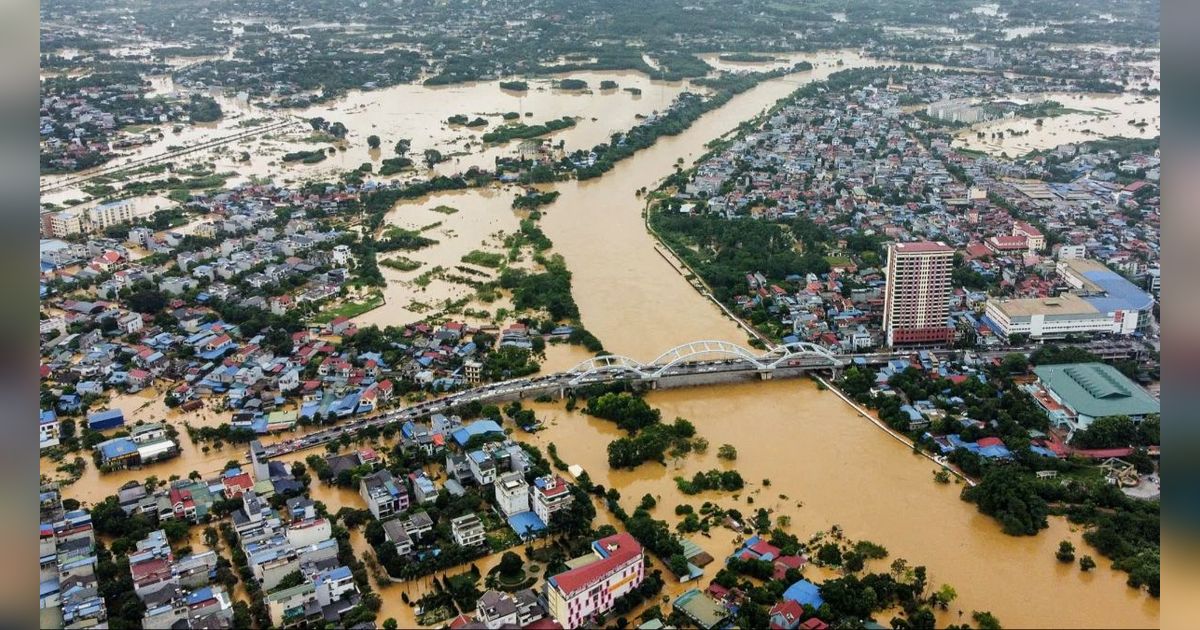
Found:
564,340 -> 846,386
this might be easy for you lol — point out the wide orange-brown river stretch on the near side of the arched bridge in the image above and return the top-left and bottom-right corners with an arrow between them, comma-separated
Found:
536,379 -> 1158,628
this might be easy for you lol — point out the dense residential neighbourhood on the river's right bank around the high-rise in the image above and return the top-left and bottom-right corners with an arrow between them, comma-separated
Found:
654,72 -> 1160,362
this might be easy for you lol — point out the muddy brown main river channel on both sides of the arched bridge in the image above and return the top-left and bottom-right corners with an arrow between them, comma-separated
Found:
528,54 -> 1159,628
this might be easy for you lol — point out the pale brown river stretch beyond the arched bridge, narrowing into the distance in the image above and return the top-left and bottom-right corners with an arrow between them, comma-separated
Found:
541,52 -> 872,361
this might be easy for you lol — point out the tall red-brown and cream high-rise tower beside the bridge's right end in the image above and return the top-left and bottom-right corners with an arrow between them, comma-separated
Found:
883,241 -> 954,346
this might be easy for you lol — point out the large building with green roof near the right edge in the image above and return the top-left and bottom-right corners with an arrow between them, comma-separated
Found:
1033,364 -> 1159,430
